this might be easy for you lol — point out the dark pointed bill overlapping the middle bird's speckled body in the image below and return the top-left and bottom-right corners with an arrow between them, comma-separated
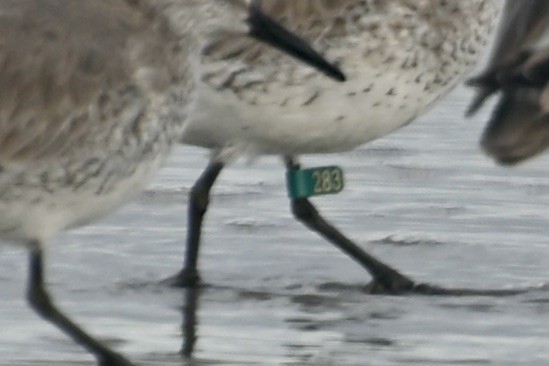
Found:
248,2 -> 346,81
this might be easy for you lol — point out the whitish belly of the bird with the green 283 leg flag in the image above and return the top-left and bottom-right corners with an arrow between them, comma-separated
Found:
183,66 -> 457,159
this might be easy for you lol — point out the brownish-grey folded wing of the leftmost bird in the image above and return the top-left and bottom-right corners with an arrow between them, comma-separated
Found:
0,0 -> 174,164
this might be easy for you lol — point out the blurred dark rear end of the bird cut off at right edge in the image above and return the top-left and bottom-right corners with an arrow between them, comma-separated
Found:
469,0 -> 549,165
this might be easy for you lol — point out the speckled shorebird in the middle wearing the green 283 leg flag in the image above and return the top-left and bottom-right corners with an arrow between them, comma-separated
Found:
170,0 -> 503,293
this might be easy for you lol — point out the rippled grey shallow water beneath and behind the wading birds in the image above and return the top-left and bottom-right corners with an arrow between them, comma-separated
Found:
0,89 -> 549,366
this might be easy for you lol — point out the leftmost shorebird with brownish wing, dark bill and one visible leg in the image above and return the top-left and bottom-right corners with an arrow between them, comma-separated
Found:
0,0 -> 343,366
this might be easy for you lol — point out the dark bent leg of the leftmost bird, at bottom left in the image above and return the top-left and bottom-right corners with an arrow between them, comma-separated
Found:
27,245 -> 133,366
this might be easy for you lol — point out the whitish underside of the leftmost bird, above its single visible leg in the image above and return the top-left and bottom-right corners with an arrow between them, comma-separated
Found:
0,157 -> 164,246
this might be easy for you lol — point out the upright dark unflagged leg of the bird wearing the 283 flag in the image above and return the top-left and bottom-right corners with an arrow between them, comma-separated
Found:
167,161 -> 224,287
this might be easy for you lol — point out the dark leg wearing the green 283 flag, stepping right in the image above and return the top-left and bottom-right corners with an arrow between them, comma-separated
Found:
286,158 -> 445,294
